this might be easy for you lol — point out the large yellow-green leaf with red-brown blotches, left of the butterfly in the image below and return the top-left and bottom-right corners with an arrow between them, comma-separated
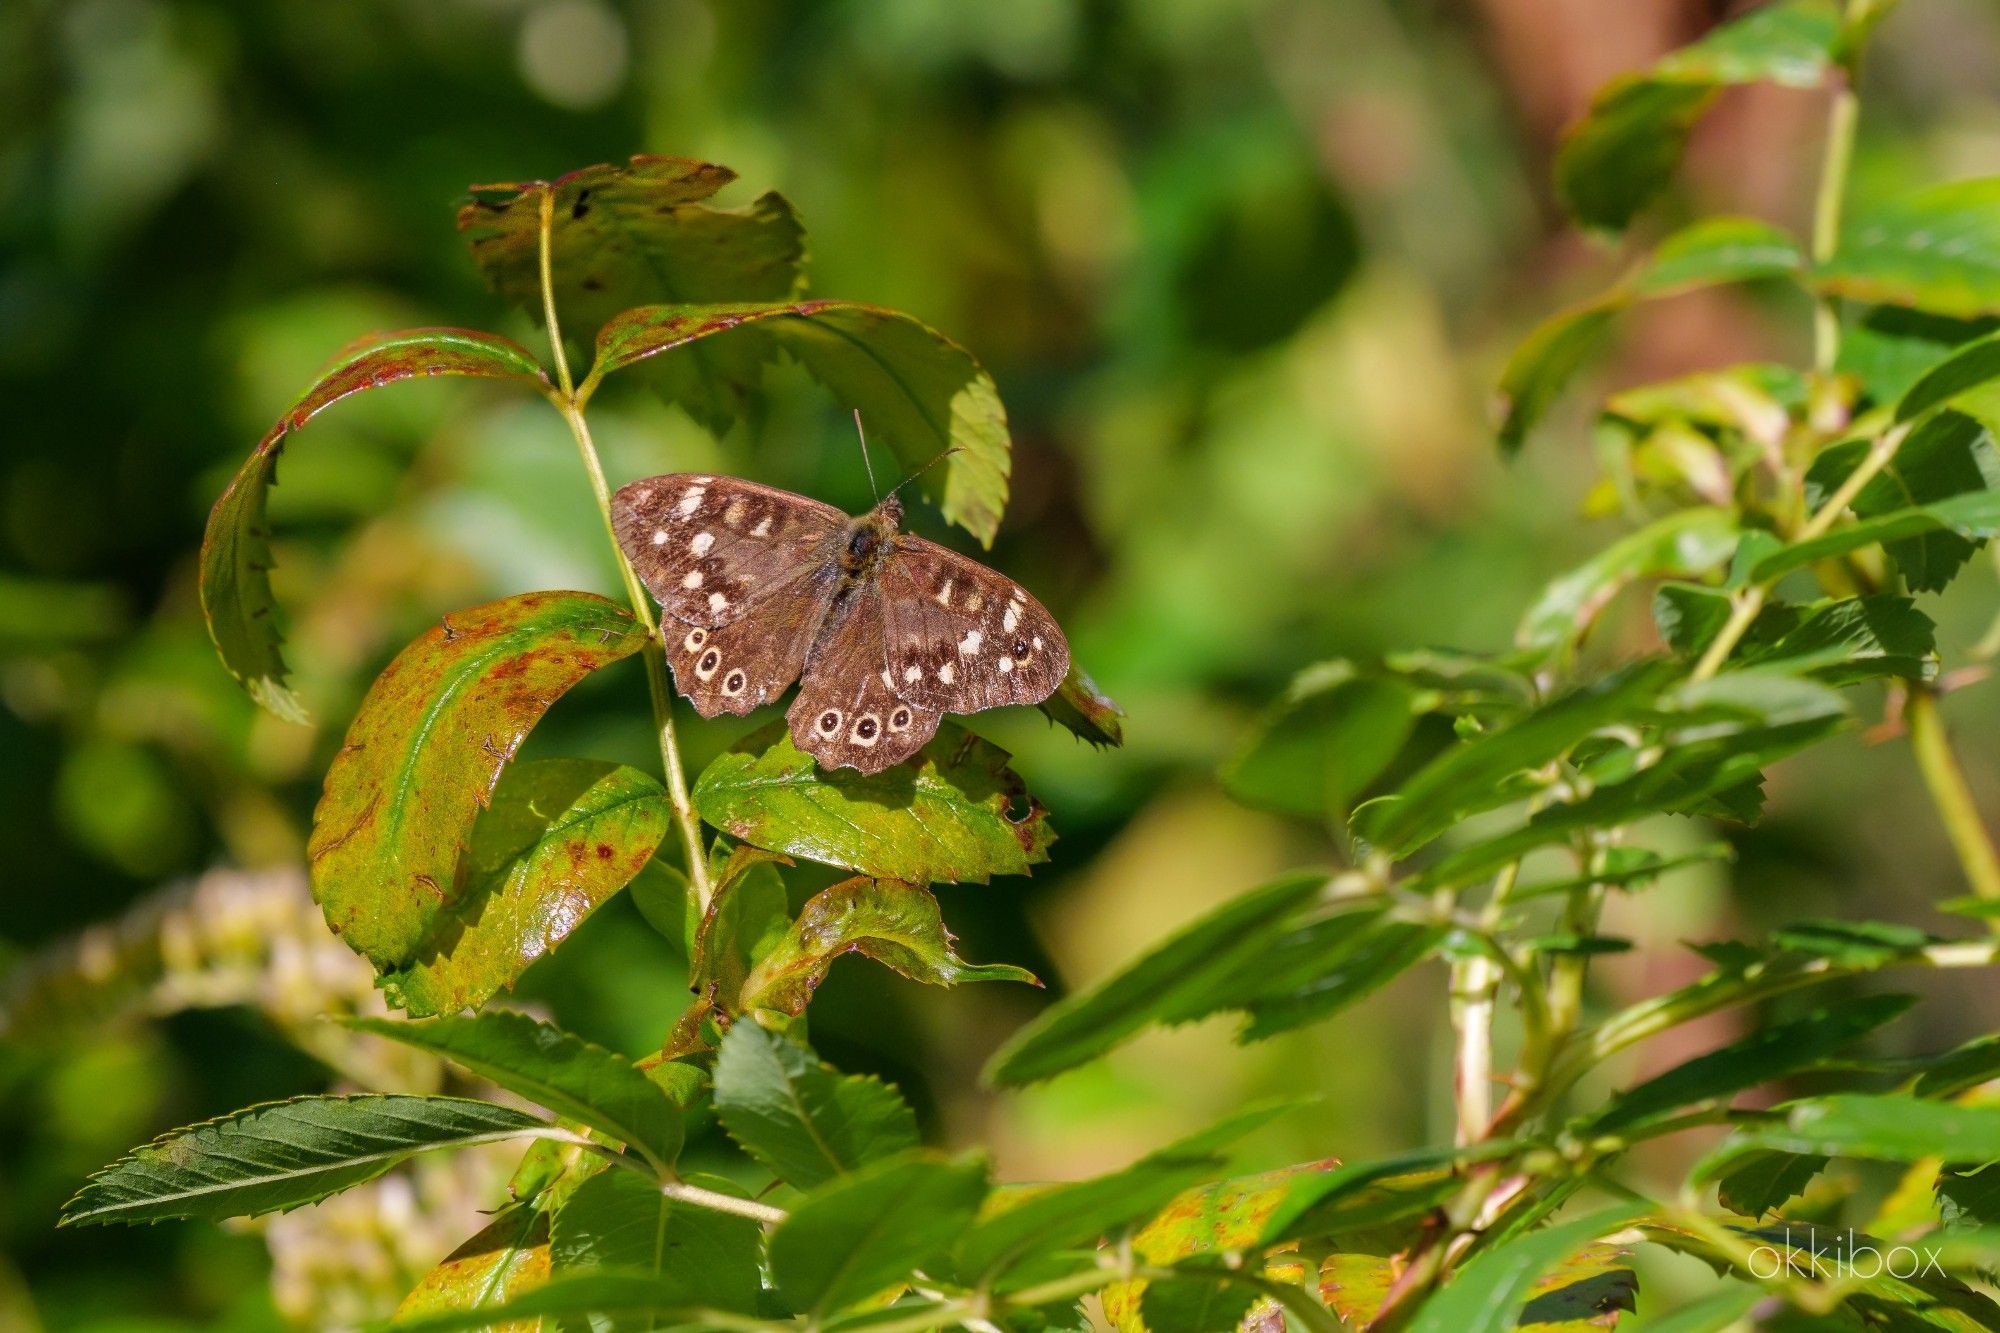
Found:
306,592 -> 652,969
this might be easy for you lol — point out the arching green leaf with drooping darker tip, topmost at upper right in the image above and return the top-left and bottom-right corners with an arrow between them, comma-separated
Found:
1556,0 -> 1842,232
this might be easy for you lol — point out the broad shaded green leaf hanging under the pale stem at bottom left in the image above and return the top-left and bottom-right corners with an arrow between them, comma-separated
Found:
550,1167 -> 764,1312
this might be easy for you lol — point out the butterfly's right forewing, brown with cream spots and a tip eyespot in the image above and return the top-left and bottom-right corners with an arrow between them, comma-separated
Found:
882,536 -> 1070,713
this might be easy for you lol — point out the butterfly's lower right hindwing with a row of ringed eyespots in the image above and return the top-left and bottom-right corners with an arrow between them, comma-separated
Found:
786,582 -> 938,773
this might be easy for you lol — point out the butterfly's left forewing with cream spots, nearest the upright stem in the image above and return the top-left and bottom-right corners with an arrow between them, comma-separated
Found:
612,472 -> 848,628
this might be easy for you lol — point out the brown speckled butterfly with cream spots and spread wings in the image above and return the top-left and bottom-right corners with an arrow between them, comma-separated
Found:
612,472 -> 1070,773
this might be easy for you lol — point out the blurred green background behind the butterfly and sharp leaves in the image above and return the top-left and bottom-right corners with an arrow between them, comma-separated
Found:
11,0 -> 2000,1329
